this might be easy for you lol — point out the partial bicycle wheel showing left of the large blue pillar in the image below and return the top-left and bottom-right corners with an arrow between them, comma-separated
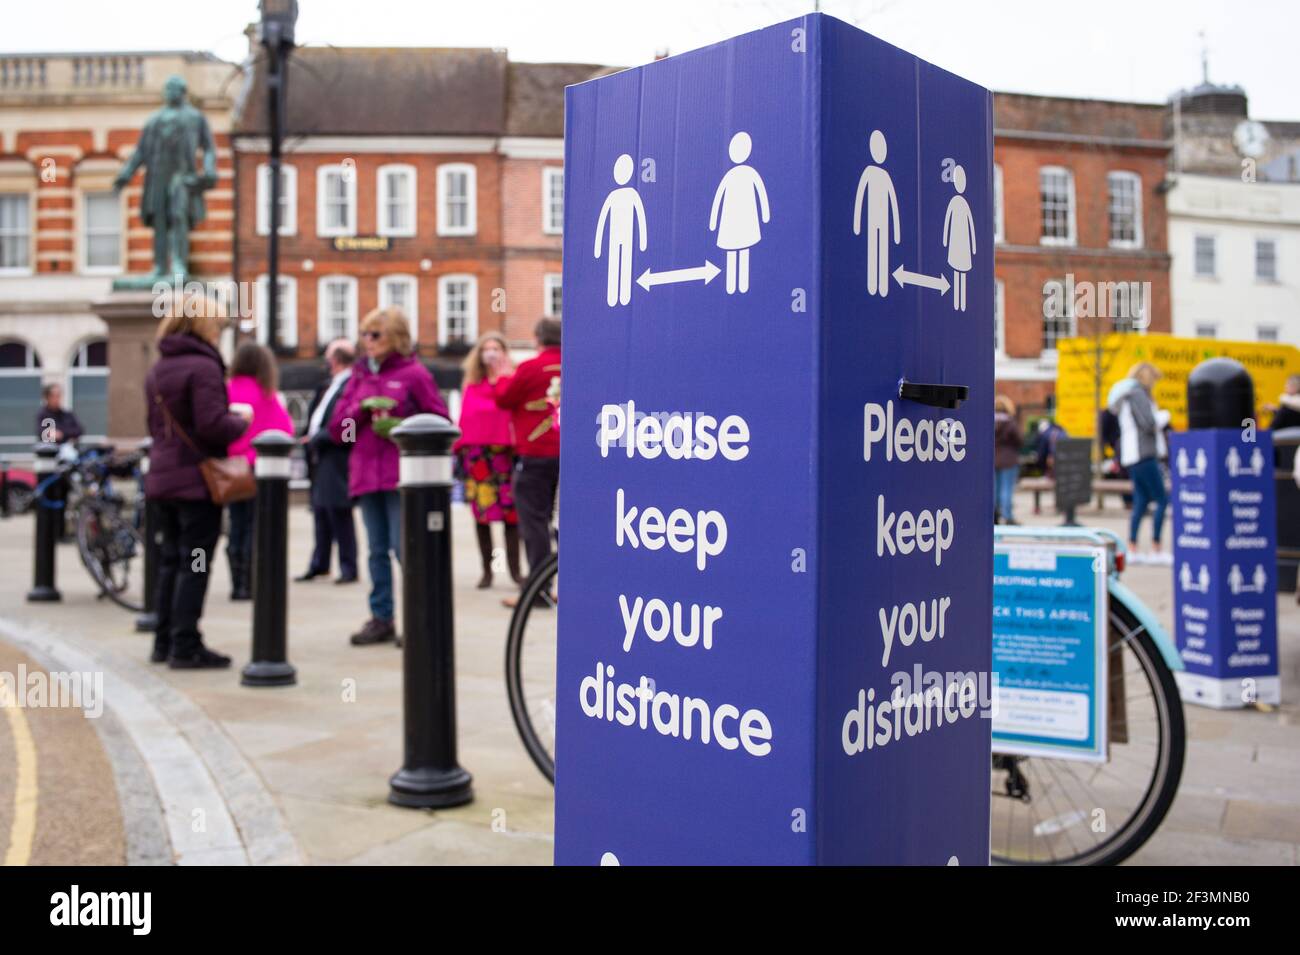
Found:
506,554 -> 559,782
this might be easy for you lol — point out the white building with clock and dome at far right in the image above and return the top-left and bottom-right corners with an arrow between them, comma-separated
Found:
1169,83 -> 1300,346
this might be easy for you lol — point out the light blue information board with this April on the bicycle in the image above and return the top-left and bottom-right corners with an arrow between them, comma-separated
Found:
993,543 -> 1109,761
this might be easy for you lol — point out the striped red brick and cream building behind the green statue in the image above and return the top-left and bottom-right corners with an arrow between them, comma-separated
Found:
0,52 -> 237,451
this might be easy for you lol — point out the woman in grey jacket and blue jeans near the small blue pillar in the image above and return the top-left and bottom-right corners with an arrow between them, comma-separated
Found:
1106,361 -> 1173,564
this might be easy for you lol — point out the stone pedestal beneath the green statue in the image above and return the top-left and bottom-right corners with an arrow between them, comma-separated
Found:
91,290 -> 159,443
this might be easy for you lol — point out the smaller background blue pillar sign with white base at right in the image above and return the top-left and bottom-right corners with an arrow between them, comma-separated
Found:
1169,429 -> 1282,709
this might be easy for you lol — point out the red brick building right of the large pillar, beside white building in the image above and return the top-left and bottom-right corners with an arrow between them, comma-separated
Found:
993,94 -> 1170,413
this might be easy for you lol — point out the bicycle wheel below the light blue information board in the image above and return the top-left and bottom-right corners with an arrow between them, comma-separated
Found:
991,598 -> 1187,865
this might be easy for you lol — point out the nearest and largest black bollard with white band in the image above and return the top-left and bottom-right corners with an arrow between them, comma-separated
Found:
389,414 -> 473,809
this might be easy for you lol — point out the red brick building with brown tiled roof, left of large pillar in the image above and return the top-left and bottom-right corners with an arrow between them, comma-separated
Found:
234,48 -> 599,386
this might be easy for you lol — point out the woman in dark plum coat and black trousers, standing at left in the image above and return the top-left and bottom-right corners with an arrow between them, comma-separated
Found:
144,299 -> 251,669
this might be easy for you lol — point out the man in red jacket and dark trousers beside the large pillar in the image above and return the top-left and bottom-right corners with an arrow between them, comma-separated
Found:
495,318 -> 560,607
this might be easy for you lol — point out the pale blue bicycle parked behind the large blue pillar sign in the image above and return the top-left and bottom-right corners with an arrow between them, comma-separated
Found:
506,528 -> 1187,865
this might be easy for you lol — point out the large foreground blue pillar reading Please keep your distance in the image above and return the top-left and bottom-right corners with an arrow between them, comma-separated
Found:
555,14 -> 993,865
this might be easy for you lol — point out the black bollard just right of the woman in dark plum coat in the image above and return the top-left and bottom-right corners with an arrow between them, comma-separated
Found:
239,430 -> 298,686
